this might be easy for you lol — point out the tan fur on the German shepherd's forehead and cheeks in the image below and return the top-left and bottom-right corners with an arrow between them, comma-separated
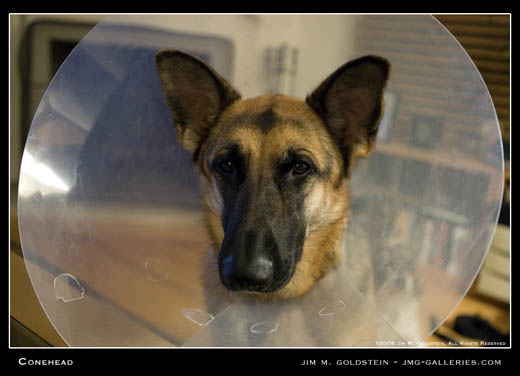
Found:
197,94 -> 348,300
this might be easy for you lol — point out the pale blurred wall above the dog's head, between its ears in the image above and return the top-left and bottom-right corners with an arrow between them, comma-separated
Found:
105,14 -> 355,97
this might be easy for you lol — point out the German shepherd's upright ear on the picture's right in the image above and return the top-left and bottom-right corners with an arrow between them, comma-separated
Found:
306,56 -> 390,173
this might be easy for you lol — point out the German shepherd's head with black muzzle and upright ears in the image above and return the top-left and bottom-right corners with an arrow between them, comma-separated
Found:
156,50 -> 389,298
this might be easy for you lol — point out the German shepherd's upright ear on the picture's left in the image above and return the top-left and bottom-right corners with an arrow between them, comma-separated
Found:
155,50 -> 240,159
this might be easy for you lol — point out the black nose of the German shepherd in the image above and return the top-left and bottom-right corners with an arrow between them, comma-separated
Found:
221,255 -> 274,292
